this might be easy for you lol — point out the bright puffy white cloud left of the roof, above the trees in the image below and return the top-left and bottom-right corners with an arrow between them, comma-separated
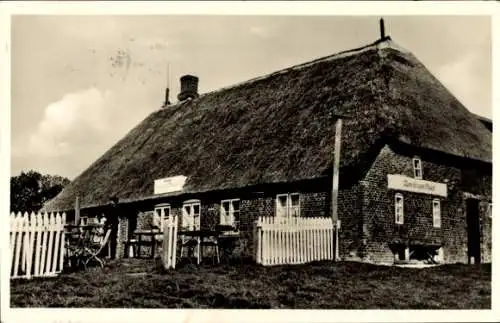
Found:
28,87 -> 111,157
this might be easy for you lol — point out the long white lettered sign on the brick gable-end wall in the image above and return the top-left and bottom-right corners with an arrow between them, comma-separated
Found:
387,174 -> 448,197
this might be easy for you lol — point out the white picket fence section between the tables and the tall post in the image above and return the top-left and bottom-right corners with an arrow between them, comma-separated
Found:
254,217 -> 334,266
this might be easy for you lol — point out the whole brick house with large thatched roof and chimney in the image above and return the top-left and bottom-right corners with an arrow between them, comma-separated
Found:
44,27 -> 492,263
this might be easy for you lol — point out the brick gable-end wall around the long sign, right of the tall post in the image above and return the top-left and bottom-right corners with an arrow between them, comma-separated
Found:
362,146 -> 491,263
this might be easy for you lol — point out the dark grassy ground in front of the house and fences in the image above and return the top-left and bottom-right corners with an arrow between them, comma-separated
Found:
11,259 -> 491,309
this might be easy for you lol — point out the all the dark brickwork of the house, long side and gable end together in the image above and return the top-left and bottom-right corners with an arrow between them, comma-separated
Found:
107,144 -> 492,263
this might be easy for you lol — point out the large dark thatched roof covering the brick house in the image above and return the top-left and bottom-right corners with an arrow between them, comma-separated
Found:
45,38 -> 491,210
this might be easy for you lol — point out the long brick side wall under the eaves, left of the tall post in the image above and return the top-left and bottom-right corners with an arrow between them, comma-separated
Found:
112,179 -> 329,256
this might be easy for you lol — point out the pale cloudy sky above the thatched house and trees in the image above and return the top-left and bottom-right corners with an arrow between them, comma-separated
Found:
11,15 -> 492,179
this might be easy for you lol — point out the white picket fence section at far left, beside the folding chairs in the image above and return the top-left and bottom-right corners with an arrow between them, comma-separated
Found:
10,213 -> 66,278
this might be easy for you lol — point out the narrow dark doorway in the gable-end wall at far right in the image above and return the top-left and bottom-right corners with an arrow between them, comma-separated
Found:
466,199 -> 481,264
